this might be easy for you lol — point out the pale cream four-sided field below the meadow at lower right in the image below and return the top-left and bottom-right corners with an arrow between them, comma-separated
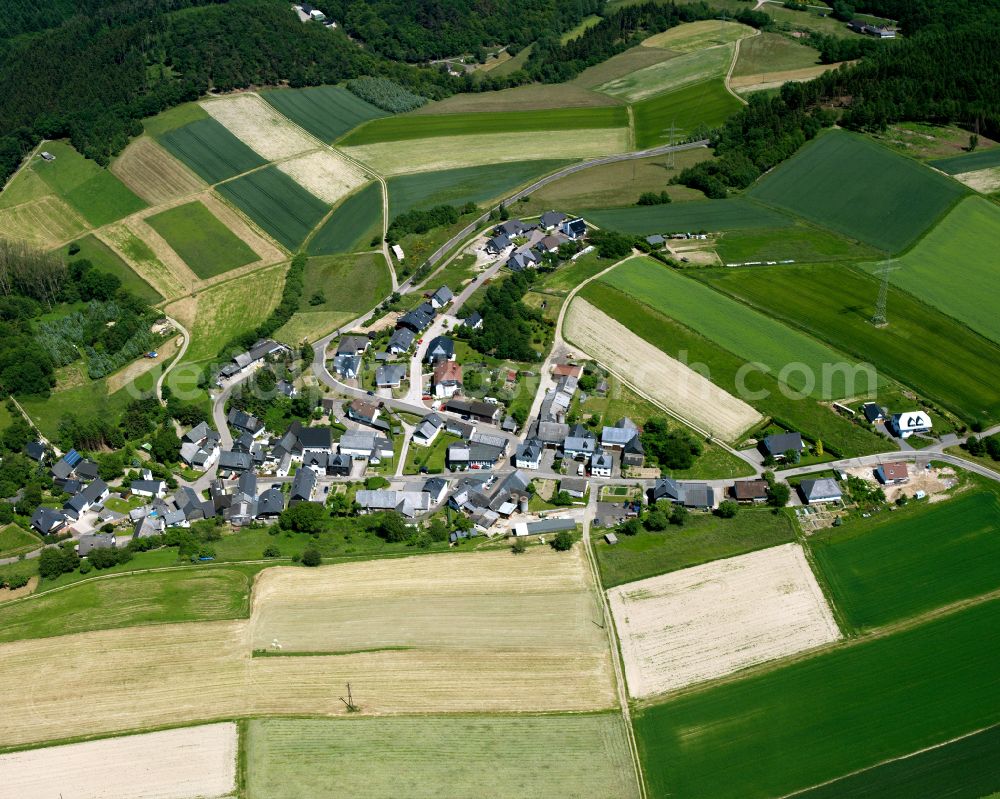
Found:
608,544 -> 840,698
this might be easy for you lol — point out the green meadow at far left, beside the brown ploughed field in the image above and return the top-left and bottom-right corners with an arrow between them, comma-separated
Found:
33,141 -> 146,227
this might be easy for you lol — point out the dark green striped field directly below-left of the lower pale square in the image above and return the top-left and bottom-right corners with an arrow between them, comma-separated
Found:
217,166 -> 329,252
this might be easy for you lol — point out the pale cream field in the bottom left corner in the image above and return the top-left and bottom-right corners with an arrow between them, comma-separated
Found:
0,723 -> 237,799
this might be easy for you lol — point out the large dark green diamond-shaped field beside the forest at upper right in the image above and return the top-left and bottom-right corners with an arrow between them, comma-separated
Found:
750,131 -> 968,252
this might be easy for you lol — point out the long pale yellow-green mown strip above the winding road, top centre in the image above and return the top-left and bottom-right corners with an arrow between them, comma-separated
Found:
345,127 -> 629,175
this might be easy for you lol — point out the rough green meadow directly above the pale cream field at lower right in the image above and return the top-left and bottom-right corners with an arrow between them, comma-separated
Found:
594,508 -> 795,588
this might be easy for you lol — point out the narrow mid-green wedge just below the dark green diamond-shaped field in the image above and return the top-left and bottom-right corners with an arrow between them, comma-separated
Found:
715,222 -> 879,264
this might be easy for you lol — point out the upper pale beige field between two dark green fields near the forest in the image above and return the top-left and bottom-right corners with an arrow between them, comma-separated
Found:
201,94 -> 318,161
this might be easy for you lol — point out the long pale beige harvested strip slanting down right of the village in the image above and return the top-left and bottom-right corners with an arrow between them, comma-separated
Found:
563,297 -> 761,441
